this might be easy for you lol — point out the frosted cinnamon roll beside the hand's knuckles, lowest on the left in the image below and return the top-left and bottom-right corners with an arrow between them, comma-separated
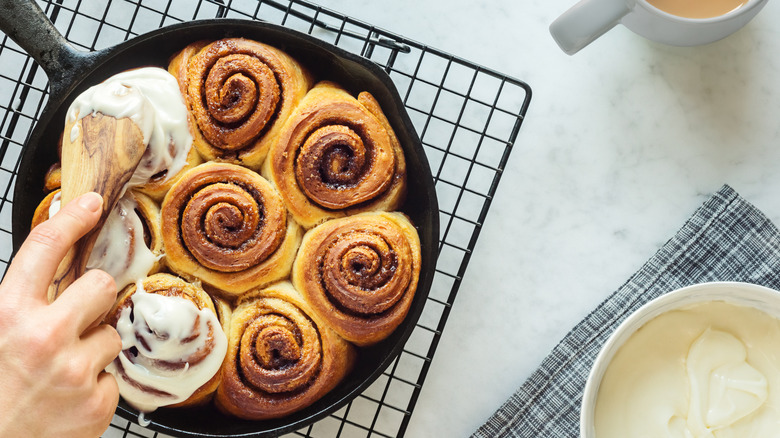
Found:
105,274 -> 230,412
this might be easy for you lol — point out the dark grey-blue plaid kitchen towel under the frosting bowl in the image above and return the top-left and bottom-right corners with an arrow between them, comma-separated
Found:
472,186 -> 780,438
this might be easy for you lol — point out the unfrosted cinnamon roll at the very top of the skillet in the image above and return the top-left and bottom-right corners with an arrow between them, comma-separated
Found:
168,38 -> 311,169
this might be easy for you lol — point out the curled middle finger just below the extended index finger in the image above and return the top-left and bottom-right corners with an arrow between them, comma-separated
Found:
51,269 -> 116,336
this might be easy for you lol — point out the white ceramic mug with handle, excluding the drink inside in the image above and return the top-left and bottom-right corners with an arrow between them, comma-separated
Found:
550,0 -> 768,55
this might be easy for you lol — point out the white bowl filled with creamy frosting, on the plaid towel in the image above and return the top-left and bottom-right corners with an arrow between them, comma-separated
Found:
580,282 -> 780,438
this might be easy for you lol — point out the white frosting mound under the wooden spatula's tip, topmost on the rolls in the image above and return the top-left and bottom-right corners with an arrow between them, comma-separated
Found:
68,67 -> 192,187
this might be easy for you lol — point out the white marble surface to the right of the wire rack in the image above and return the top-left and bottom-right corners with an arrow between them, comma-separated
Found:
318,0 -> 780,437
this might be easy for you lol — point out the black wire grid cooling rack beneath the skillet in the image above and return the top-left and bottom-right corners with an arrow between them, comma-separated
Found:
0,0 -> 531,438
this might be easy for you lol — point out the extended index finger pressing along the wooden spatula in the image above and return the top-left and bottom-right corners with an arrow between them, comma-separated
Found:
5,193 -> 103,299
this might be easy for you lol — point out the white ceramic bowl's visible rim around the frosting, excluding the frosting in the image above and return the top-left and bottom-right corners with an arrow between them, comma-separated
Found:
580,282 -> 780,438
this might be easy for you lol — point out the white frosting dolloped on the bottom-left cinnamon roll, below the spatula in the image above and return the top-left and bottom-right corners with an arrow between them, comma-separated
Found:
106,290 -> 227,412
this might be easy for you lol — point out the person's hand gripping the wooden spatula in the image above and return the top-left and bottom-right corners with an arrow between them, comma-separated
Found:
0,193 -> 122,438
